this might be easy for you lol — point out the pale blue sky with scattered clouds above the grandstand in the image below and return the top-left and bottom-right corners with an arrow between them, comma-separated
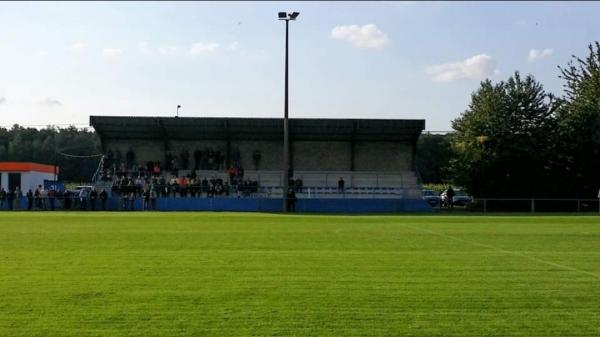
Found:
0,1 -> 600,130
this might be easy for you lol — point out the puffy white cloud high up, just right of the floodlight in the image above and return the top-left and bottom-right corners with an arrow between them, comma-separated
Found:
331,23 -> 390,49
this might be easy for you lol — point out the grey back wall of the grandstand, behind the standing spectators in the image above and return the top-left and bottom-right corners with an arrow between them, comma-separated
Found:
105,140 -> 413,172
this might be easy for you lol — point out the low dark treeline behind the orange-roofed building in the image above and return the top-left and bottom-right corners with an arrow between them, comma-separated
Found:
0,124 -> 101,182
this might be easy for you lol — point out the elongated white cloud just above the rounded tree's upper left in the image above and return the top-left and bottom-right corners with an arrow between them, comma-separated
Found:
426,54 -> 500,82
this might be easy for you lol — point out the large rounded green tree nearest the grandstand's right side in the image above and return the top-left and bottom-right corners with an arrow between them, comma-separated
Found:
451,72 -> 560,197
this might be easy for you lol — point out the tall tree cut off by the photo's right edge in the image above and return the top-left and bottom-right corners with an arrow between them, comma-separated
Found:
557,42 -> 600,198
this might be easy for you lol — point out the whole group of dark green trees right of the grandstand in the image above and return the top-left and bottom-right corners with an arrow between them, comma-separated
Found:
417,42 -> 600,198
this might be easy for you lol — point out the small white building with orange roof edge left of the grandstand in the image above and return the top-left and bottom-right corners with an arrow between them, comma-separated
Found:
0,162 -> 59,193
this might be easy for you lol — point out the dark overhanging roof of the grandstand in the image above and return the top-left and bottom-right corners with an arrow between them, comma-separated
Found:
90,116 -> 425,141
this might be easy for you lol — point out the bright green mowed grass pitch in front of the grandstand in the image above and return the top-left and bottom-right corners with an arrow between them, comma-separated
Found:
0,212 -> 600,337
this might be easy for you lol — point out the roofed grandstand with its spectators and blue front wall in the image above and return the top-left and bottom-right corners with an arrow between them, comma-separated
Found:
85,116 -> 428,212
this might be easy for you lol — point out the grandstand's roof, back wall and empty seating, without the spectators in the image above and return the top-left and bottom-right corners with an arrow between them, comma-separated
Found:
90,116 -> 425,210
